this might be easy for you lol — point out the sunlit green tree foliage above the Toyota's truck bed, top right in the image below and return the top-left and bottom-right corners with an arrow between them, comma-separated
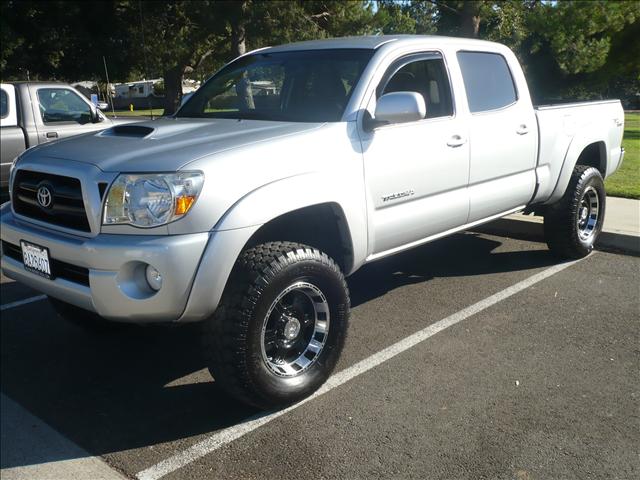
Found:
522,1 -> 640,101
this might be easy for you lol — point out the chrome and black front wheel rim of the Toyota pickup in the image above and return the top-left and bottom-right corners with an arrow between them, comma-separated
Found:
260,282 -> 330,377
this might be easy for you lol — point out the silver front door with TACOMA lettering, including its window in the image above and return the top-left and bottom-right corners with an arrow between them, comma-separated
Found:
361,52 -> 469,257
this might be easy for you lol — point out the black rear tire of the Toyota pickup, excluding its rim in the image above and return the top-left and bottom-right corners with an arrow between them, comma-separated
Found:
544,165 -> 607,259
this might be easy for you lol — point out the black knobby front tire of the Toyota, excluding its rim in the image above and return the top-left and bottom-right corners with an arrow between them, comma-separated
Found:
203,242 -> 350,409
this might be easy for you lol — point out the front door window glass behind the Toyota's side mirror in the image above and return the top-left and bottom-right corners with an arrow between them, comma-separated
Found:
378,58 -> 453,118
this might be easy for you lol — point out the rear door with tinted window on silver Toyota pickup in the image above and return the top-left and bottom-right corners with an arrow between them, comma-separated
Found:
457,51 -> 538,222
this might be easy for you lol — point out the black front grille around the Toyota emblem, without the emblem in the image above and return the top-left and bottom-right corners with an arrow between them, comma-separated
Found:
13,170 -> 91,232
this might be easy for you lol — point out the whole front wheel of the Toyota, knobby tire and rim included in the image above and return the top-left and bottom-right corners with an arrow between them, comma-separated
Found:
204,242 -> 349,408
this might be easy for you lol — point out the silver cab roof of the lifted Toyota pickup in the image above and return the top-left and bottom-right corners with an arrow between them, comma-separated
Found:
264,35 -> 498,52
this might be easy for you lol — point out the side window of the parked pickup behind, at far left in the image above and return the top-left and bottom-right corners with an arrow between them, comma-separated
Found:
38,88 -> 91,125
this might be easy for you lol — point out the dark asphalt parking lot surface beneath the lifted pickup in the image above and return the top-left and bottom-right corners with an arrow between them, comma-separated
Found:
0,233 -> 640,480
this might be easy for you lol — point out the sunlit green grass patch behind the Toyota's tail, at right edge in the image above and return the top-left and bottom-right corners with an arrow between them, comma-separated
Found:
605,113 -> 640,198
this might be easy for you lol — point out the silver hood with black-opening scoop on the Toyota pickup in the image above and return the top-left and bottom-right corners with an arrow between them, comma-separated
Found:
25,118 -> 322,172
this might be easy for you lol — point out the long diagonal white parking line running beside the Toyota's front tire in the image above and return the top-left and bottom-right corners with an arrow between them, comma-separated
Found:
136,260 -> 580,480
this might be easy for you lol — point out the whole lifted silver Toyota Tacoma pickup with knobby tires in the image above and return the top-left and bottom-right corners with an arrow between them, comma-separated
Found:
0,36 -> 624,408
